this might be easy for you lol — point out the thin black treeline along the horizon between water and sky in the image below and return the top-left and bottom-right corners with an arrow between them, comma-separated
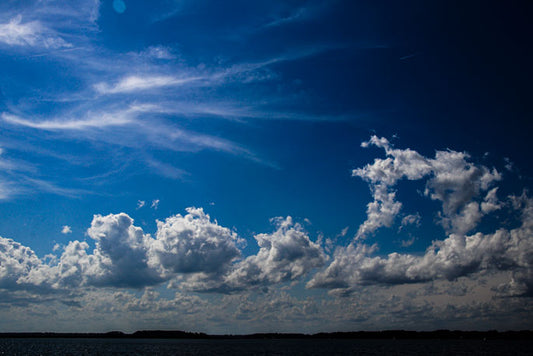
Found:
0,330 -> 533,340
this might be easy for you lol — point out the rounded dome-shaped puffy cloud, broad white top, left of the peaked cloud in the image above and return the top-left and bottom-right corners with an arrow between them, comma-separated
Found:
150,208 -> 240,273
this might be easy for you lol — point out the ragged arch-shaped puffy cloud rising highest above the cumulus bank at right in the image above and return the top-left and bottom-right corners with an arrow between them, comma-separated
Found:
352,136 -> 501,239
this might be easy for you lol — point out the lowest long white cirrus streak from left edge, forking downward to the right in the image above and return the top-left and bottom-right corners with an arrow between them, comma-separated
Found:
0,103 -> 271,185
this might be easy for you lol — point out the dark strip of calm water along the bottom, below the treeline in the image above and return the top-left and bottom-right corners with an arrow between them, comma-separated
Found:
0,339 -> 533,356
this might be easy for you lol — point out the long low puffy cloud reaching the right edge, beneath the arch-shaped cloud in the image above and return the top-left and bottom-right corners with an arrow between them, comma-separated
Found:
308,196 -> 533,295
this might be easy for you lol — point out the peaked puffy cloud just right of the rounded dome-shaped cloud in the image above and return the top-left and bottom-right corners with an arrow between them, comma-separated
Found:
225,216 -> 326,289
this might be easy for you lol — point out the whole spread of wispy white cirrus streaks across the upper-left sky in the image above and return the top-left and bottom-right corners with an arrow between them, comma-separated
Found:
0,0 -> 354,200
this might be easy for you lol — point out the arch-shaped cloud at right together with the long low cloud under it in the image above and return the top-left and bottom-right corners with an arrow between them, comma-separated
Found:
307,136 -> 533,294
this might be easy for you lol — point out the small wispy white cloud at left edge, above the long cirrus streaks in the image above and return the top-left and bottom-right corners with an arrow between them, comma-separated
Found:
0,15 -> 72,49
